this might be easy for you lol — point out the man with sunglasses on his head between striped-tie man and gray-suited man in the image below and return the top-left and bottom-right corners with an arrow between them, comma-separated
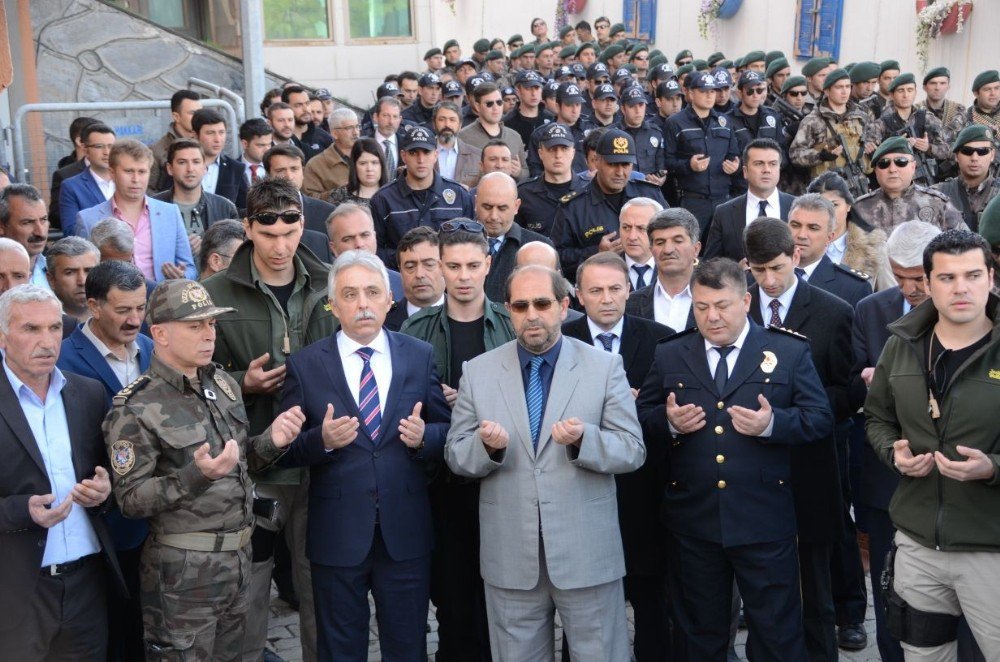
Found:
400,218 -> 514,662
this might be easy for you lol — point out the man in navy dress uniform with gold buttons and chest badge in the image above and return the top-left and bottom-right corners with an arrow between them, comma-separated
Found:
637,258 -> 833,662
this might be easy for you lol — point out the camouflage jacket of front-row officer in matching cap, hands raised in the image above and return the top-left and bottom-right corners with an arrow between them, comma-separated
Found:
104,354 -> 284,533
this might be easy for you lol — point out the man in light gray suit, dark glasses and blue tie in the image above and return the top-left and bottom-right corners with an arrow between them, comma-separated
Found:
445,265 -> 646,662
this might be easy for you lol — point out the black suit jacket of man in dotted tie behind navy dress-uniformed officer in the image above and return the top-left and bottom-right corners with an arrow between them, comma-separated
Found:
750,279 -> 854,543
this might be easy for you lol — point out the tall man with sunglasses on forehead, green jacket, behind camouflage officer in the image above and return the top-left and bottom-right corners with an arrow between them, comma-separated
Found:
204,178 -> 337,660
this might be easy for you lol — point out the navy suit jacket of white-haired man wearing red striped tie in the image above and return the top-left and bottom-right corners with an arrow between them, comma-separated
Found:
279,331 -> 451,566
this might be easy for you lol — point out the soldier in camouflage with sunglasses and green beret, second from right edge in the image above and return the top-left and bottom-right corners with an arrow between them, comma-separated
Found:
854,136 -> 968,235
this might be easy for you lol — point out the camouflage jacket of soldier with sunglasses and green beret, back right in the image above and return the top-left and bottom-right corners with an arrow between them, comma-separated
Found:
854,184 -> 968,235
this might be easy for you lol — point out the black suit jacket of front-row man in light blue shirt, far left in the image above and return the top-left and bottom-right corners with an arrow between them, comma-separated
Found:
0,370 -> 125,640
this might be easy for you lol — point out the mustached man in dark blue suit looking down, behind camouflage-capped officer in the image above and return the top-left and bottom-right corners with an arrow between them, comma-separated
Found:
56,260 -> 153,660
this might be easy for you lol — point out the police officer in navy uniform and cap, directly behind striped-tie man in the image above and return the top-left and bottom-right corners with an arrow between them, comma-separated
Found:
371,125 -> 475,269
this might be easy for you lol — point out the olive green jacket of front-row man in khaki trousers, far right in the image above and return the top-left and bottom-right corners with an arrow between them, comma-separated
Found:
865,294 -> 1000,551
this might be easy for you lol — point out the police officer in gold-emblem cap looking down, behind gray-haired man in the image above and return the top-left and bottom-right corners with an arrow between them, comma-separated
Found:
550,129 -> 668,279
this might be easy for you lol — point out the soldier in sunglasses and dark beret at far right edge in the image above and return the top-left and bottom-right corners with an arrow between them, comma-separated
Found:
933,124 -> 1000,232
